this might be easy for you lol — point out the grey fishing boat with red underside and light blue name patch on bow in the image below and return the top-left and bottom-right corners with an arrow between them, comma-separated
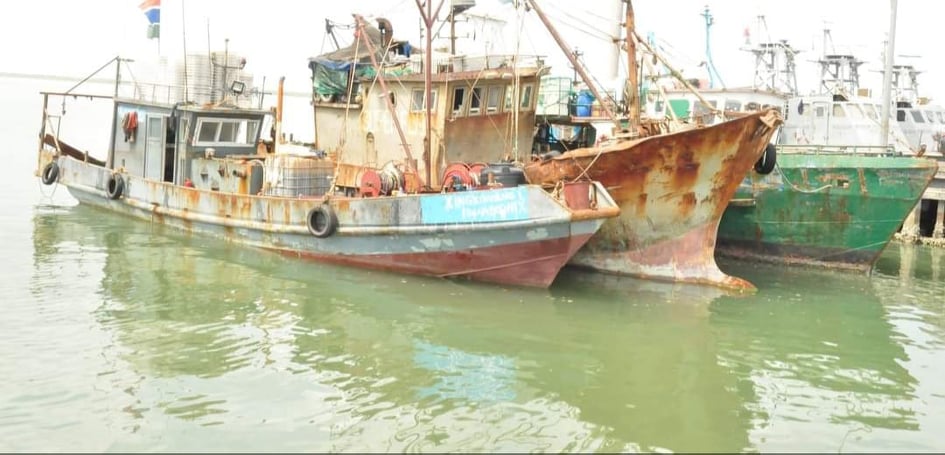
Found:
36,46 -> 619,287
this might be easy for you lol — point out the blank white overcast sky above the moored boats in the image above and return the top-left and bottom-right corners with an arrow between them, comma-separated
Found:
0,0 -> 945,101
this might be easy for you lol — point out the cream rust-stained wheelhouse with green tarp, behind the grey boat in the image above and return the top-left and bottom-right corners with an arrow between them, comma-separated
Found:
309,19 -> 548,190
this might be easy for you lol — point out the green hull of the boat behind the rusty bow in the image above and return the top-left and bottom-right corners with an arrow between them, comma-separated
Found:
716,147 -> 938,271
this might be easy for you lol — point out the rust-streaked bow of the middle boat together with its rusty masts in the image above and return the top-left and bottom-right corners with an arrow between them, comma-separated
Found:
525,0 -> 781,289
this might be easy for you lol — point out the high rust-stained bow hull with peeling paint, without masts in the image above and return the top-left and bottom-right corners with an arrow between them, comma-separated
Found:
526,110 -> 781,289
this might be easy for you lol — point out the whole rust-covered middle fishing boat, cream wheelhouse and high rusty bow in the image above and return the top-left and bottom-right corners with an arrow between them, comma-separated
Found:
308,2 -> 779,288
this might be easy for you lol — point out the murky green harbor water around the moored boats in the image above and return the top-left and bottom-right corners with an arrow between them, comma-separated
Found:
0,77 -> 945,452
